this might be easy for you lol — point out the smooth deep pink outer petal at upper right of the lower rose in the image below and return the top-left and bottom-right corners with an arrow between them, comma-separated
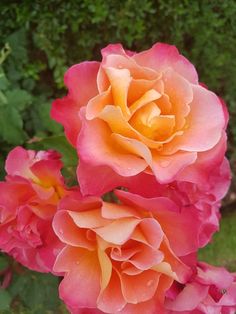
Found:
115,190 -> 201,256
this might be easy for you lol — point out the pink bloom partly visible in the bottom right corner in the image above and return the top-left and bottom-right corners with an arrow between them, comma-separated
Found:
165,262 -> 236,314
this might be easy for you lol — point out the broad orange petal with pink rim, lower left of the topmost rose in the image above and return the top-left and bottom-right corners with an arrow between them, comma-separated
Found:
78,109 -> 147,176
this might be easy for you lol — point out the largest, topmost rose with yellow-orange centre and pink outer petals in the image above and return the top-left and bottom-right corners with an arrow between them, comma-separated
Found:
52,43 -> 228,194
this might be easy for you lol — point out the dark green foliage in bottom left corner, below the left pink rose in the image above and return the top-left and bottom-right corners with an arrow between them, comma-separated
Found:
0,255 -> 66,314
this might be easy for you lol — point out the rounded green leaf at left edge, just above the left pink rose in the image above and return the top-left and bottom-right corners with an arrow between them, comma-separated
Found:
0,106 -> 26,145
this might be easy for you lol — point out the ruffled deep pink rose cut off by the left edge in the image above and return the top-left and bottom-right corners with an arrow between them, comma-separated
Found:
0,147 -> 66,272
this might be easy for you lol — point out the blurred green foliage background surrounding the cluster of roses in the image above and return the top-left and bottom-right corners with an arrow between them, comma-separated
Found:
0,0 -> 236,313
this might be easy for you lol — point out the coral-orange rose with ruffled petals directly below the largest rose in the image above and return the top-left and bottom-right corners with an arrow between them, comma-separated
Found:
53,191 -> 206,314
